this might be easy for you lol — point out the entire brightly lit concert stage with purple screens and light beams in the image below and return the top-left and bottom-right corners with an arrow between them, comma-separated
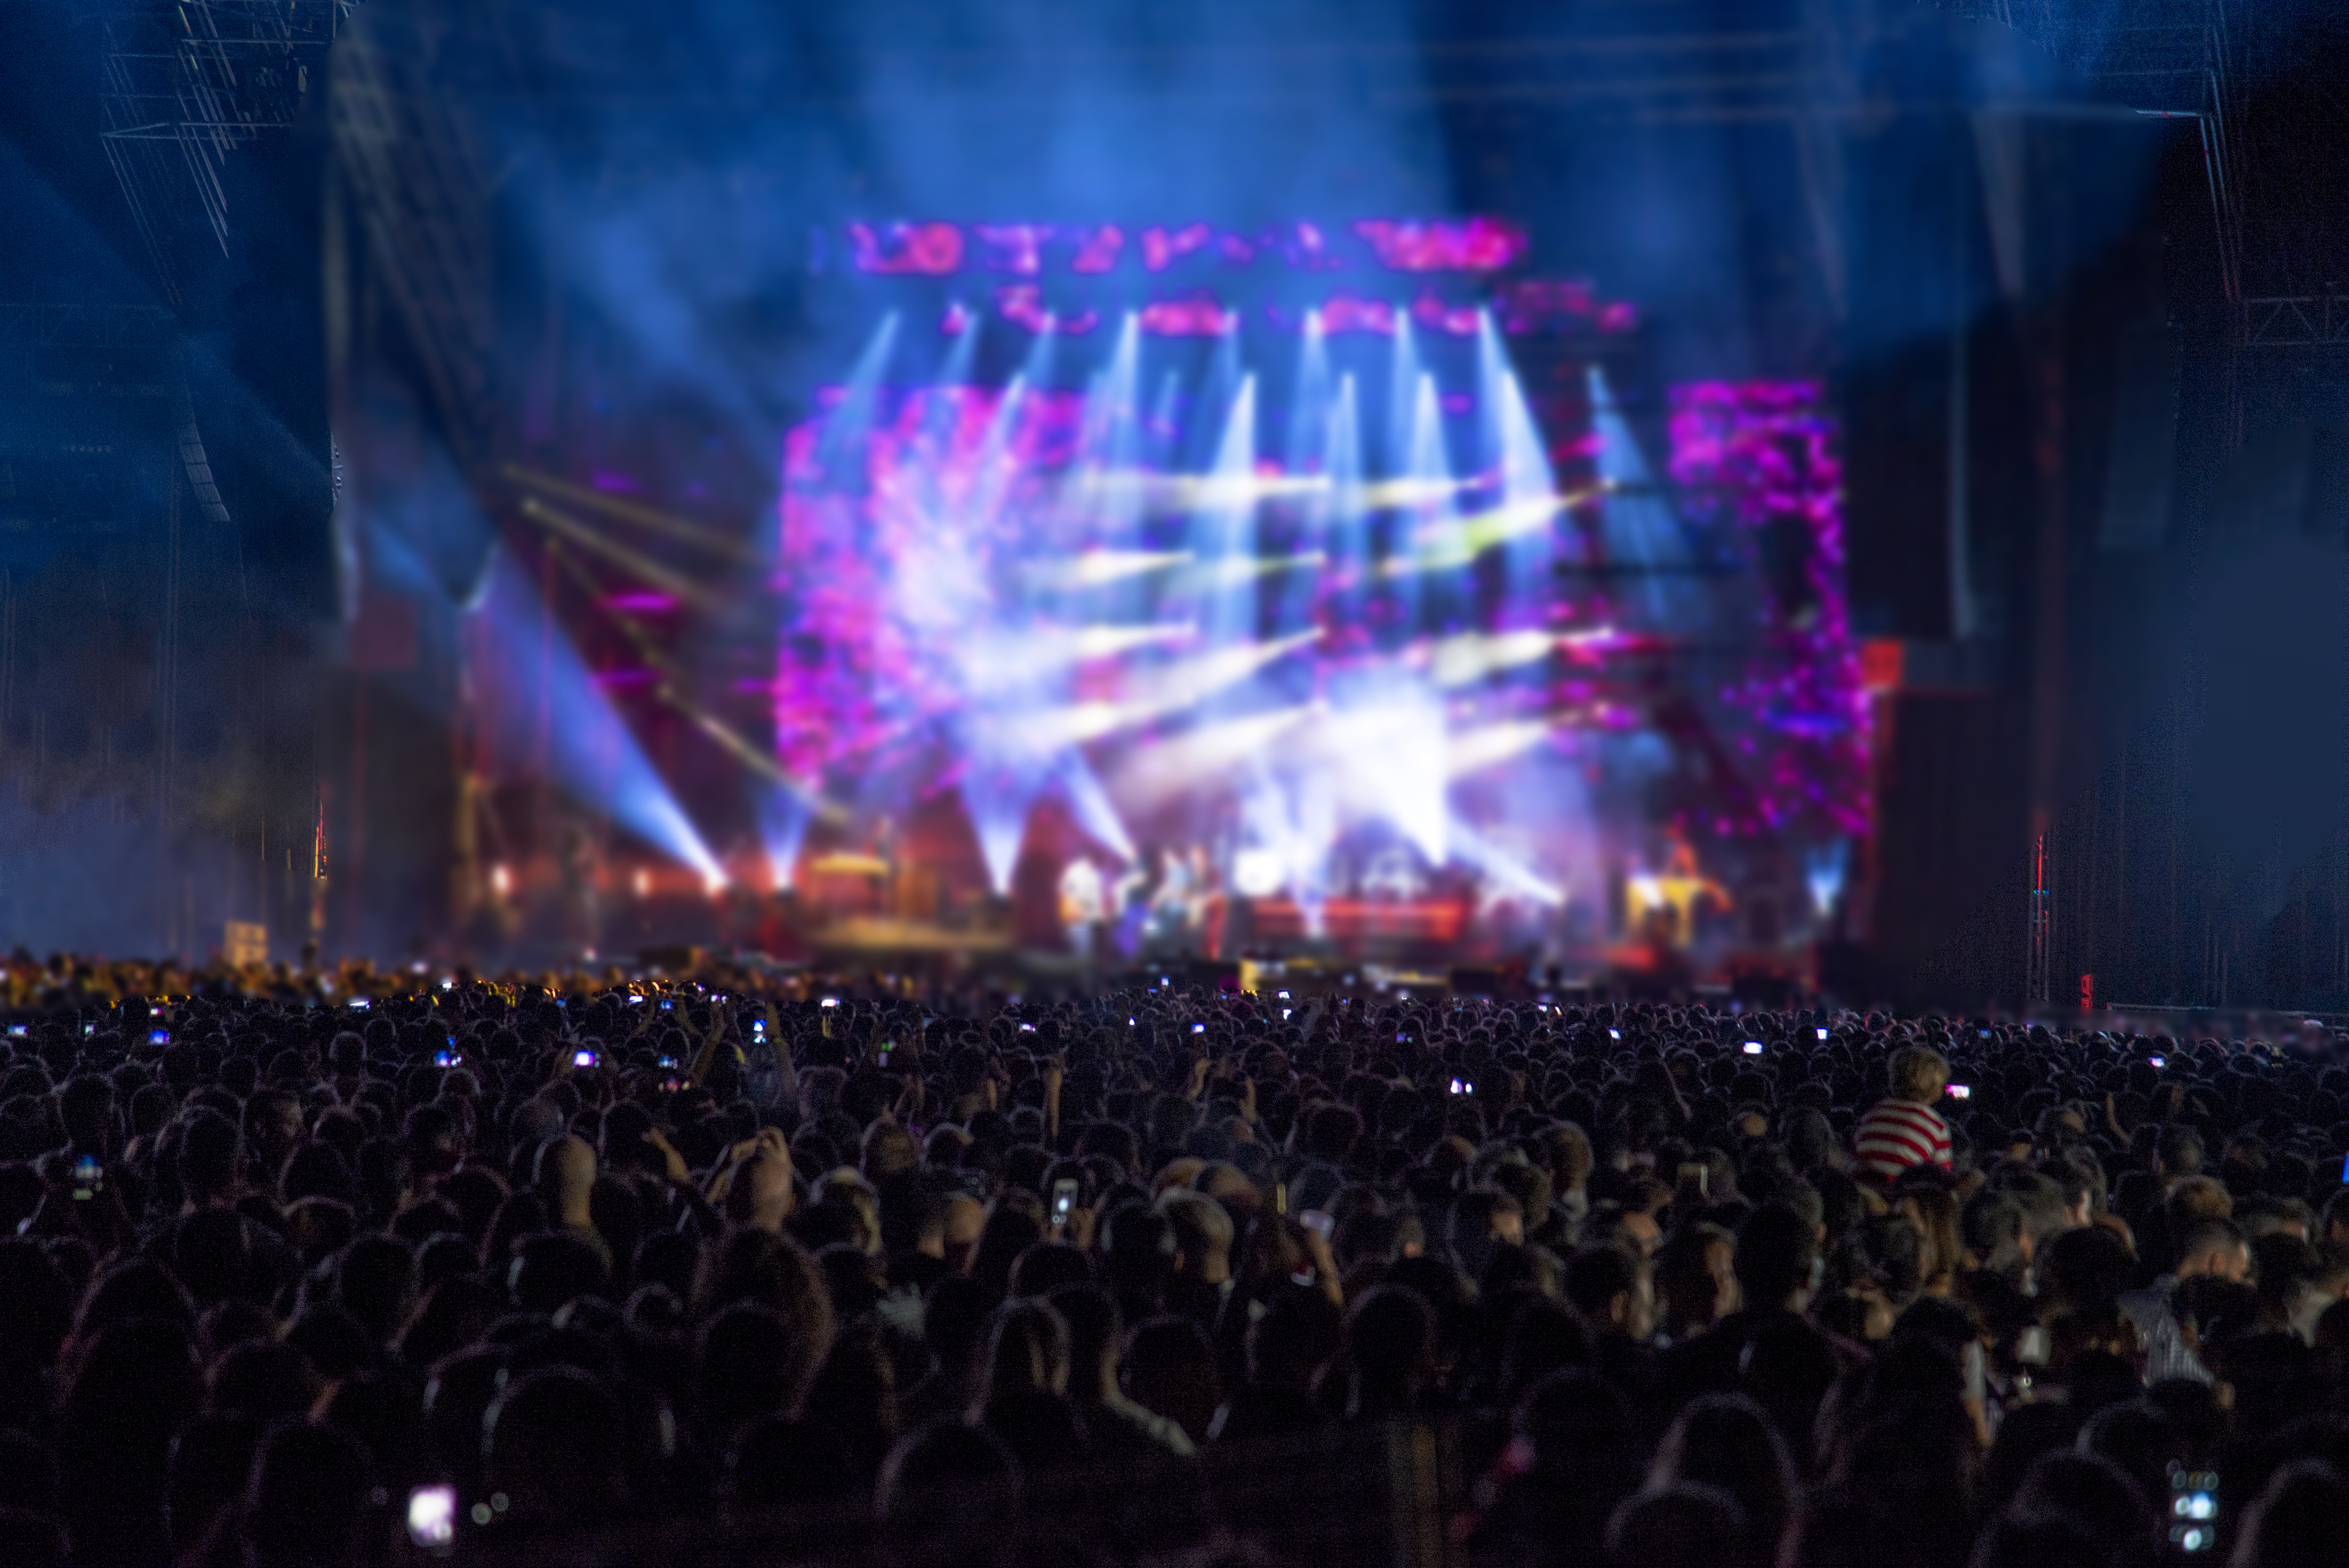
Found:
413,218 -> 1868,979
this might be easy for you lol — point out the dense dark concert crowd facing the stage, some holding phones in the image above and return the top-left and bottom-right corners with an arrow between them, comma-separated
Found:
0,974 -> 2349,1568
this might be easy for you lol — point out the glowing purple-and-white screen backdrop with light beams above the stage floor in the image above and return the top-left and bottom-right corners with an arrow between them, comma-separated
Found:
770,272 -> 1868,930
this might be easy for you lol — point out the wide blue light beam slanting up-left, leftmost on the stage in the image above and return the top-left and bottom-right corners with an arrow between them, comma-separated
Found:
472,547 -> 726,887
